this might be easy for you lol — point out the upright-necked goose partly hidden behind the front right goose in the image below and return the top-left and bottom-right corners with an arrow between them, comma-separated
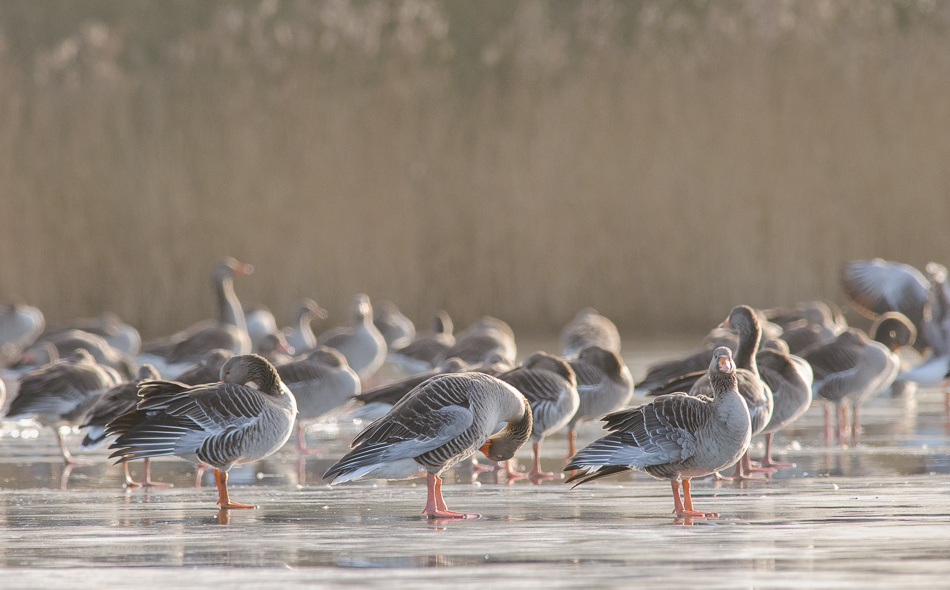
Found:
648,305 -> 774,479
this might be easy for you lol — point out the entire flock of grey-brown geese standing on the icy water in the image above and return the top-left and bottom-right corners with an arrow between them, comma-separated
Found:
0,258 -> 950,518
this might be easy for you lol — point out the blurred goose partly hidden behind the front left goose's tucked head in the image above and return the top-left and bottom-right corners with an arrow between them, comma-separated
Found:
277,346 -> 360,454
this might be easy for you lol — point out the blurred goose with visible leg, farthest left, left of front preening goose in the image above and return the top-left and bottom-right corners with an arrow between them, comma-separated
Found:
6,349 -> 120,465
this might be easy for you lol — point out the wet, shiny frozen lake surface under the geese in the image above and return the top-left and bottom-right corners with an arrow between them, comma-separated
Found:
0,342 -> 950,589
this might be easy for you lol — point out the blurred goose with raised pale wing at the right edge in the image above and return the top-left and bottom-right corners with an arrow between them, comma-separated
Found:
841,258 -> 950,356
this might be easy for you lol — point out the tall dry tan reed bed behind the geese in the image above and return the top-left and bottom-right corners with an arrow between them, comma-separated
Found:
0,0 -> 950,336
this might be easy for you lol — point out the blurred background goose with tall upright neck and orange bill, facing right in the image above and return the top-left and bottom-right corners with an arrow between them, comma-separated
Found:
137,258 -> 254,375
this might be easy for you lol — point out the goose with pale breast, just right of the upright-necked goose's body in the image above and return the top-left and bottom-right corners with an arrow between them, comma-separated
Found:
755,349 -> 814,469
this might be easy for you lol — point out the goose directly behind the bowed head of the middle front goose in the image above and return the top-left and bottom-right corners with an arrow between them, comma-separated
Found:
498,352 -> 580,483
